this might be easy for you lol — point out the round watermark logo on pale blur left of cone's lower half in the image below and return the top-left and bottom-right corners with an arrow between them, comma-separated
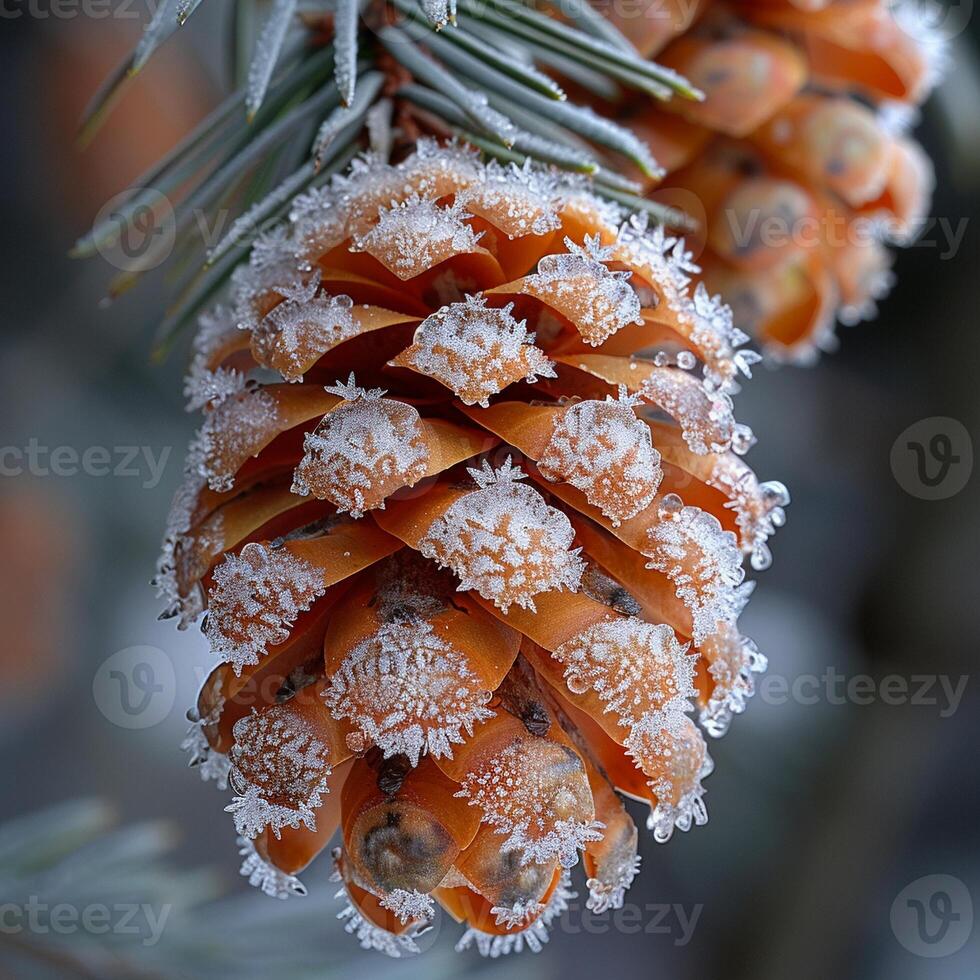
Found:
92,646 -> 177,728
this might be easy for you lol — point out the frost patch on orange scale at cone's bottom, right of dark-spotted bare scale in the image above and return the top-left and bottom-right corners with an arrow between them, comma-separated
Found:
456,742 -> 604,868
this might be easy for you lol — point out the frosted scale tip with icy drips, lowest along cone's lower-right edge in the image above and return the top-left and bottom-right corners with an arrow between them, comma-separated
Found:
626,708 -> 714,844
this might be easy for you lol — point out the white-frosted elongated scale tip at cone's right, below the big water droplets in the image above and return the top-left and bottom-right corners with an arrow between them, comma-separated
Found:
644,494 -> 748,644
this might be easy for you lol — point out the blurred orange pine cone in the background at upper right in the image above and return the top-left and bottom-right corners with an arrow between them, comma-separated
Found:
604,0 -> 945,361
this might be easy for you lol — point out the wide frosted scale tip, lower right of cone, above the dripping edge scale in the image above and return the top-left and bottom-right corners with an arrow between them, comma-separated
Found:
554,616 -> 694,726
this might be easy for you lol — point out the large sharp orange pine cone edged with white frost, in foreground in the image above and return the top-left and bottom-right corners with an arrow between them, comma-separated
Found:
167,142 -> 788,956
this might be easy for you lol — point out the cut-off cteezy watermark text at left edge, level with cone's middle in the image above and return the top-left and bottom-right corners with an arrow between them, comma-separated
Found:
0,438 -> 173,490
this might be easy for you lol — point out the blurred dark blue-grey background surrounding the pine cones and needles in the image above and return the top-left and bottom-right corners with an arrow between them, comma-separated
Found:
0,0 -> 980,980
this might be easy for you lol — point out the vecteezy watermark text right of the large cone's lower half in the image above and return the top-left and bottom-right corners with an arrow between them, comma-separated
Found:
756,667 -> 970,718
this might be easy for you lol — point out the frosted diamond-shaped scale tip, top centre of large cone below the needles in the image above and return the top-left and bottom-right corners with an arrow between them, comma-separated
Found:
354,195 -> 480,279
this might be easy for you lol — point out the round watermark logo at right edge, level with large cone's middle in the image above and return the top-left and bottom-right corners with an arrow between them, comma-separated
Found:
890,415 -> 973,500
